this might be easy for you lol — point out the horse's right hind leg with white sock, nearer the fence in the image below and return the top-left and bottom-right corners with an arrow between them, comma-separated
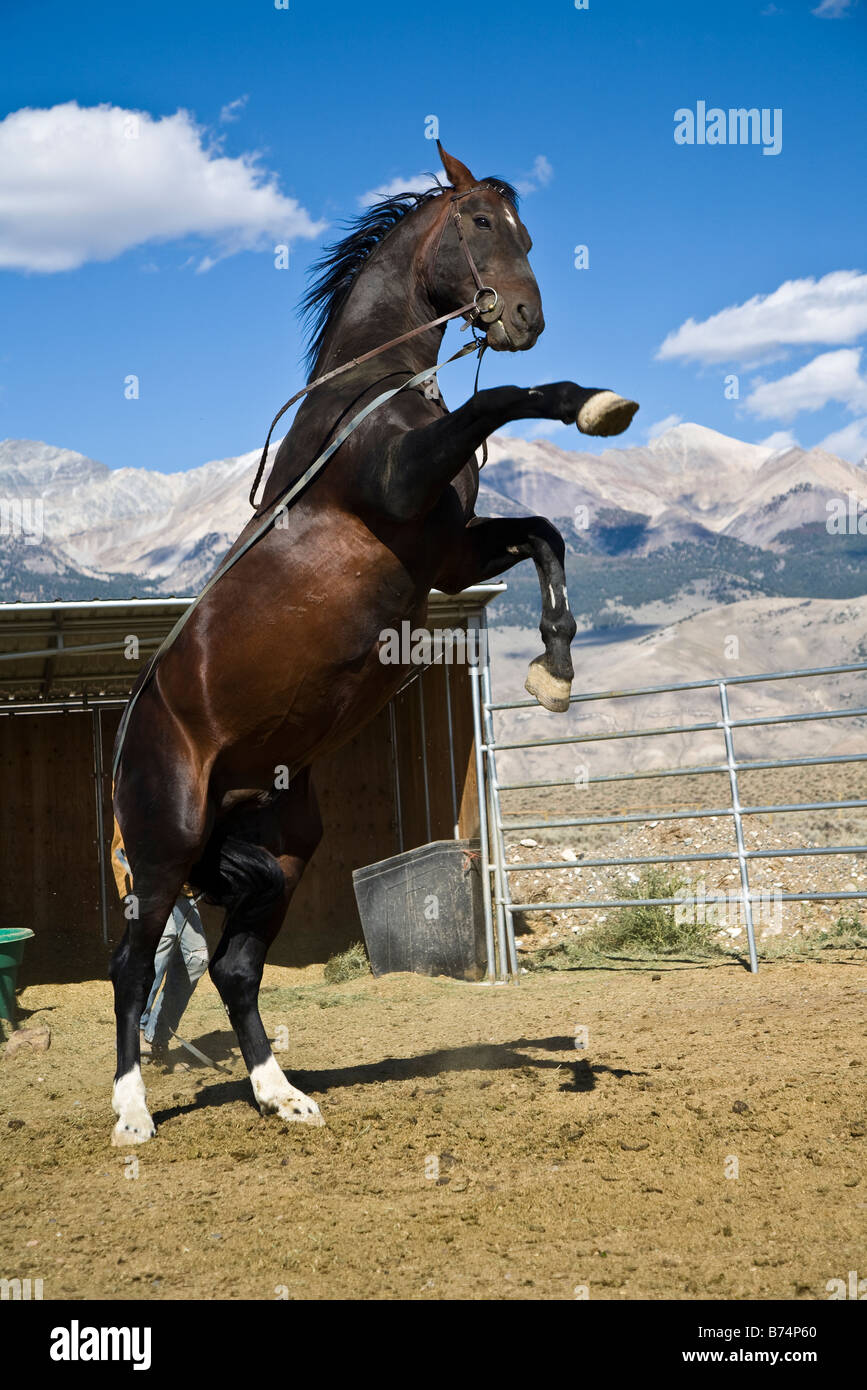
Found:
211,770 -> 325,1125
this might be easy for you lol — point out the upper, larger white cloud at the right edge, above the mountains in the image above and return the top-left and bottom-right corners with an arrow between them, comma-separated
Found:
656,270 -> 867,363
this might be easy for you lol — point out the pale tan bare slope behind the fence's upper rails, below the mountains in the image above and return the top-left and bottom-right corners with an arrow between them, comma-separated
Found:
490,598 -> 867,781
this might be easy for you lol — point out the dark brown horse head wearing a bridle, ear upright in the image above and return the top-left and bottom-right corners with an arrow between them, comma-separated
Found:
429,140 -> 545,352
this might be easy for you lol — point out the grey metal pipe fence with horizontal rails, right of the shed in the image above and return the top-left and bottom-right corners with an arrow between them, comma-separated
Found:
477,662 -> 867,979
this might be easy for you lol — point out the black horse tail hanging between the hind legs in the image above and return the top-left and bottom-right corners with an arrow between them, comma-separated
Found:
188,817 -> 286,926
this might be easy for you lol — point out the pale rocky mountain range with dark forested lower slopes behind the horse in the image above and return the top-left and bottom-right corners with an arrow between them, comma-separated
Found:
0,424 -> 867,627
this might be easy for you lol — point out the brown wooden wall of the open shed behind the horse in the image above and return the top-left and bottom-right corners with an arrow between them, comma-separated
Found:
0,666 -> 478,981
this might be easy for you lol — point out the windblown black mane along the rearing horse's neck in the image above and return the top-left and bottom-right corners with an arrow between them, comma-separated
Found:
300,178 -> 518,371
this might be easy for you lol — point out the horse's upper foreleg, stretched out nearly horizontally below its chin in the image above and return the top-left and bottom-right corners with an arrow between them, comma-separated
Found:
365,381 -> 638,521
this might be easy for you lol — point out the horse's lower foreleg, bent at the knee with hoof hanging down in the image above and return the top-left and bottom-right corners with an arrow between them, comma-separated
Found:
436,517 -> 575,712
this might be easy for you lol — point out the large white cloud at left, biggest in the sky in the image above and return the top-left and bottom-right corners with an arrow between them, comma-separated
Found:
0,101 -> 325,271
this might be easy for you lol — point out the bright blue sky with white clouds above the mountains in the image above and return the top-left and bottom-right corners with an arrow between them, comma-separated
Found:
0,0 -> 867,471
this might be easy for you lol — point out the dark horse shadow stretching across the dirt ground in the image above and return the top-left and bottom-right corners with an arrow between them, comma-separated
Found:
148,1033 -> 643,1122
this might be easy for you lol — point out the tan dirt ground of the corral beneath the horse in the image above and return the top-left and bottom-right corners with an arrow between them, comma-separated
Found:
0,952 -> 867,1300
